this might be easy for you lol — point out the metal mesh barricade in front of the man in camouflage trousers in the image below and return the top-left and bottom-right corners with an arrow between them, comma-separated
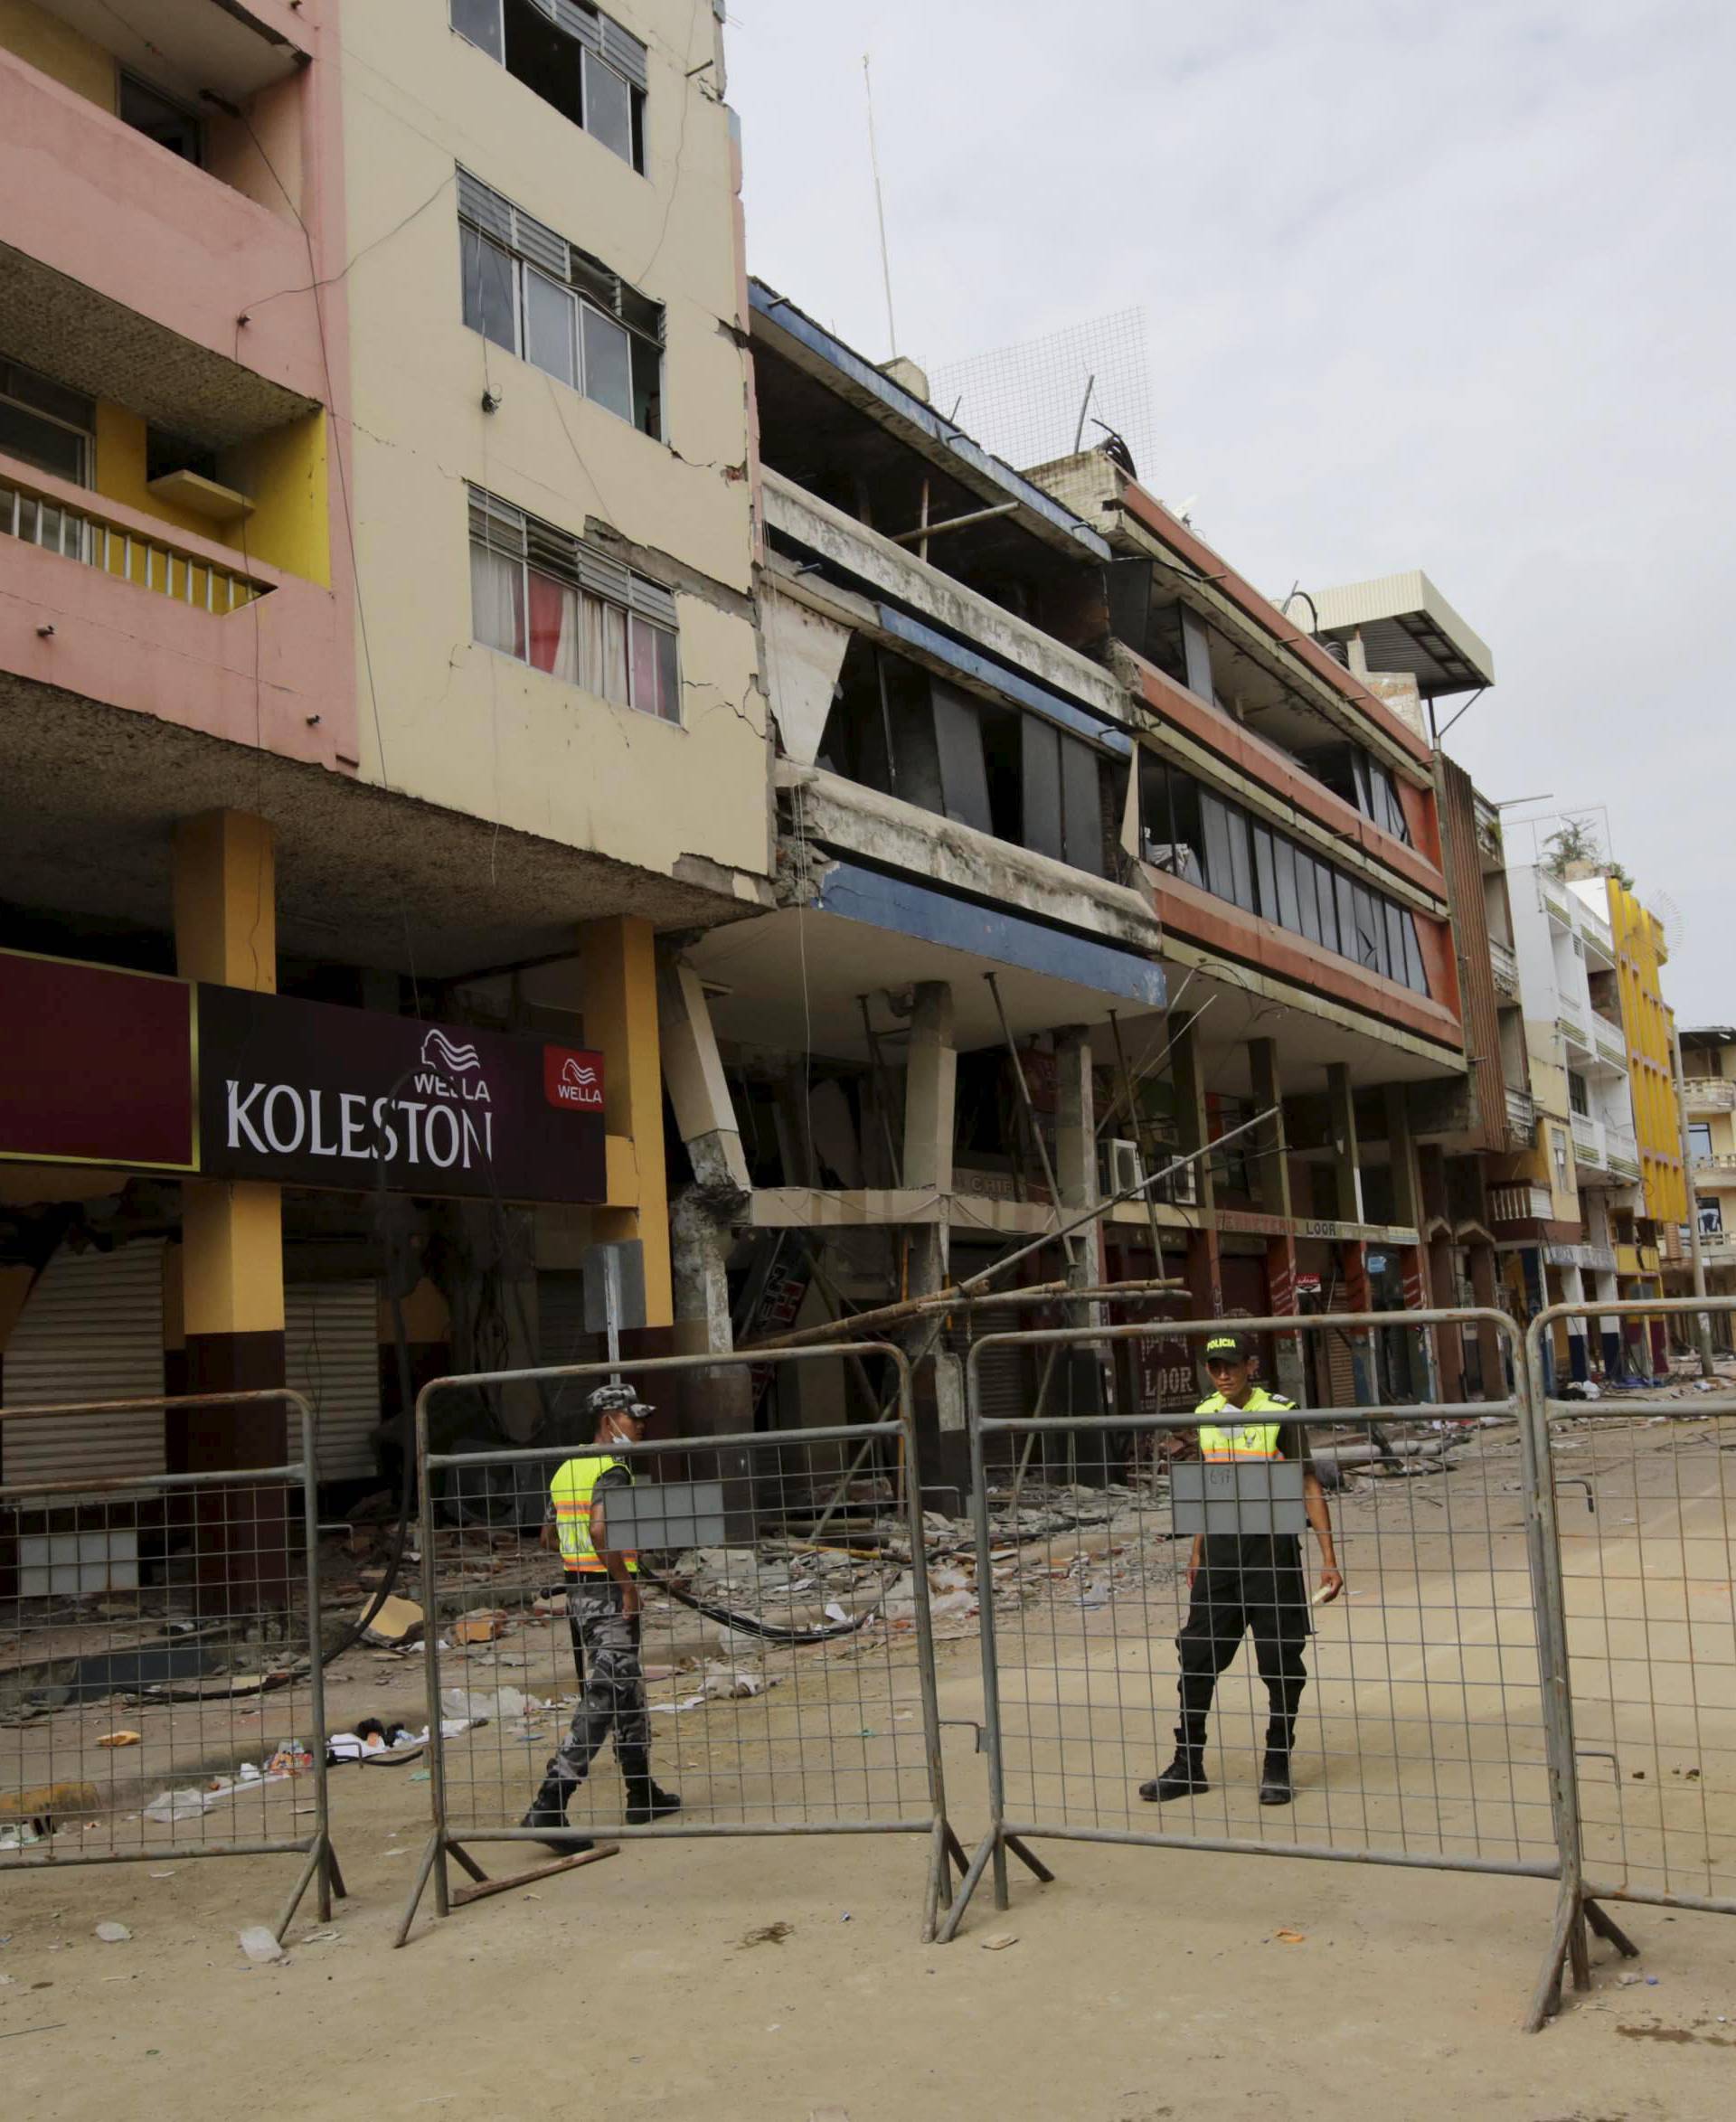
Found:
397,1341 -> 964,1944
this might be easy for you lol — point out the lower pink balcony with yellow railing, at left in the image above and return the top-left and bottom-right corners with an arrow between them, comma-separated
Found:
0,457 -> 356,766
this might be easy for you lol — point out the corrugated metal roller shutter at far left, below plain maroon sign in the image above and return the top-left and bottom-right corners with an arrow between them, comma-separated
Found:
0,1240 -> 164,1484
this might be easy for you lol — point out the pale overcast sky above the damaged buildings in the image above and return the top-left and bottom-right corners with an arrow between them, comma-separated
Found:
728,0 -> 1736,1025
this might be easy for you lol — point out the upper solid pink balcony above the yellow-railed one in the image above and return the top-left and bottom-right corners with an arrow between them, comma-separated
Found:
0,45 -> 326,450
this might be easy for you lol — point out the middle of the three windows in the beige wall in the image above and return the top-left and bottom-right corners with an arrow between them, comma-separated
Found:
458,170 -> 662,439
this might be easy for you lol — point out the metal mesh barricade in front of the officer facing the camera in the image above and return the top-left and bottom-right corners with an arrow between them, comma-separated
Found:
942,1309 -> 1604,2023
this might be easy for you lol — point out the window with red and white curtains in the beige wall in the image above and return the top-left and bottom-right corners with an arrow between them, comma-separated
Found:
469,486 -> 681,723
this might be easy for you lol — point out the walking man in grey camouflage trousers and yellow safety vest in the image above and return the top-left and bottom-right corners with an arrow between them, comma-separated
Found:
518,1386 -> 681,1854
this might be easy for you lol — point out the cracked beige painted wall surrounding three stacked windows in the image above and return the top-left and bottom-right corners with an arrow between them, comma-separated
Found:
344,0 -> 769,874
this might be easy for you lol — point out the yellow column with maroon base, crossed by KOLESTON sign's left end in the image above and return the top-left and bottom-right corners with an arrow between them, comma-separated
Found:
167,811 -> 288,1473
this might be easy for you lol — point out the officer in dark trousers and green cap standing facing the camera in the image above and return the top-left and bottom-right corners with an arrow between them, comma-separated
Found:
1139,1333 -> 1344,1806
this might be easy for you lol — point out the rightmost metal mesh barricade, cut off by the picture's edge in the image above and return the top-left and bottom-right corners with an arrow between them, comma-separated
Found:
1528,1297 -> 1736,1974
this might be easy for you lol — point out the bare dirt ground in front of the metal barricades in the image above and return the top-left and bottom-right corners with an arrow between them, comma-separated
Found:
0,1700 -> 1736,2122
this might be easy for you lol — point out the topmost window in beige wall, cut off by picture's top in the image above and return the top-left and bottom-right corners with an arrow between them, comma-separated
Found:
450,0 -> 649,172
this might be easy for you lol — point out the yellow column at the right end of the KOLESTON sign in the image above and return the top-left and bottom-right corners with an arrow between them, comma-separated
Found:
580,915 -> 675,1326
